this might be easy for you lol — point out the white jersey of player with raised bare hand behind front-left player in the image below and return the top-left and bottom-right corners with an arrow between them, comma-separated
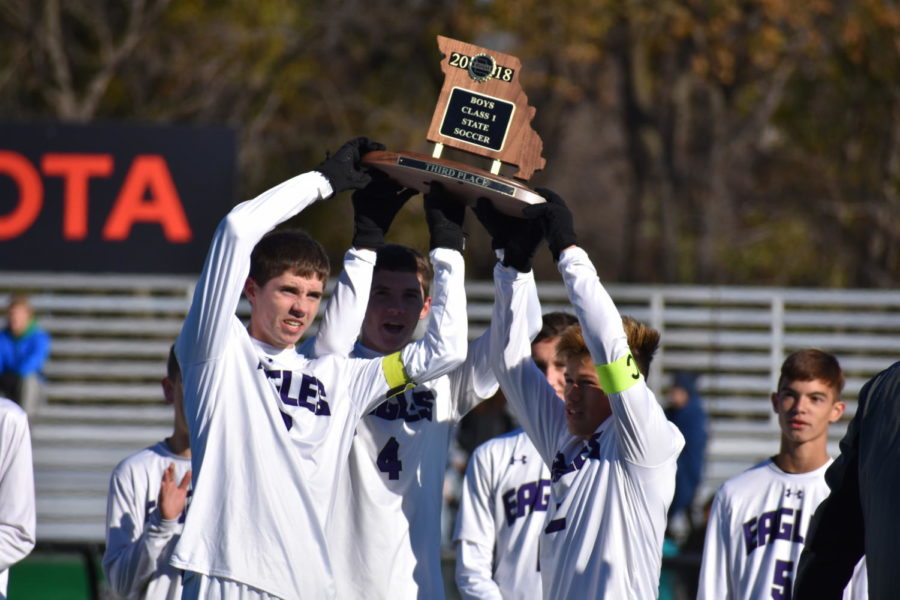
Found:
103,442 -> 191,600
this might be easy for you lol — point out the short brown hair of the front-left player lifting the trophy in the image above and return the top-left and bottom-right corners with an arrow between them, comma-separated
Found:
250,229 -> 331,286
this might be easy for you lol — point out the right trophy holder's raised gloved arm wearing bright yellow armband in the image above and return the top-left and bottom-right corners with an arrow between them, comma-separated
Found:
525,190 -> 684,466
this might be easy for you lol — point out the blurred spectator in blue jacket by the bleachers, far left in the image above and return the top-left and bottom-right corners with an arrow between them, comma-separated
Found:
0,294 -> 50,413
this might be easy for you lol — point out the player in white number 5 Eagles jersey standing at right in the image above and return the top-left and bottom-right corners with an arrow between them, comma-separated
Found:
697,349 -> 866,600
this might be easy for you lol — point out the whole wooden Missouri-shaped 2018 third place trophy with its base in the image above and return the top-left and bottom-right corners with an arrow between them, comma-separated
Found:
362,36 -> 546,216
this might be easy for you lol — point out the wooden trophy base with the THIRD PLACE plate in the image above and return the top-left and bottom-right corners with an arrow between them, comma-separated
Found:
362,150 -> 545,217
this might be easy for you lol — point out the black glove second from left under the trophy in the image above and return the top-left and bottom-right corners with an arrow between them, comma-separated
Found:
352,171 -> 418,249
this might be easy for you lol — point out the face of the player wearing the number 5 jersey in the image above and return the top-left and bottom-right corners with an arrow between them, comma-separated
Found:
772,379 -> 844,444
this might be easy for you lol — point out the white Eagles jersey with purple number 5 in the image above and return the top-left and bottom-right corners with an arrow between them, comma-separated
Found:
697,459 -> 867,600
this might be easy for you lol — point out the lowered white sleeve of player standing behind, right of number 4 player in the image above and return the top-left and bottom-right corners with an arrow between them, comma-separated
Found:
453,445 -> 503,600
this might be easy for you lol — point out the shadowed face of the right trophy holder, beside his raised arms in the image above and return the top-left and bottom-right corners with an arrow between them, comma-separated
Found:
565,356 -> 612,438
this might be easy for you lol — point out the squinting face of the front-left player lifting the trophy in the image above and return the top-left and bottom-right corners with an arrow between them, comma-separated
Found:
244,271 -> 324,348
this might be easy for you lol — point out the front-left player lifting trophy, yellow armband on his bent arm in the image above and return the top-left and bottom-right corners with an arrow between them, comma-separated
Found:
171,138 -> 467,600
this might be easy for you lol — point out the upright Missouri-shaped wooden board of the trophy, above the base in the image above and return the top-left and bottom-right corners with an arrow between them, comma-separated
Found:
427,35 -> 546,181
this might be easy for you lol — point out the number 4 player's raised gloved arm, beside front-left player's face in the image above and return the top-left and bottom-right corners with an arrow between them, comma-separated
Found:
300,176 -> 416,356
